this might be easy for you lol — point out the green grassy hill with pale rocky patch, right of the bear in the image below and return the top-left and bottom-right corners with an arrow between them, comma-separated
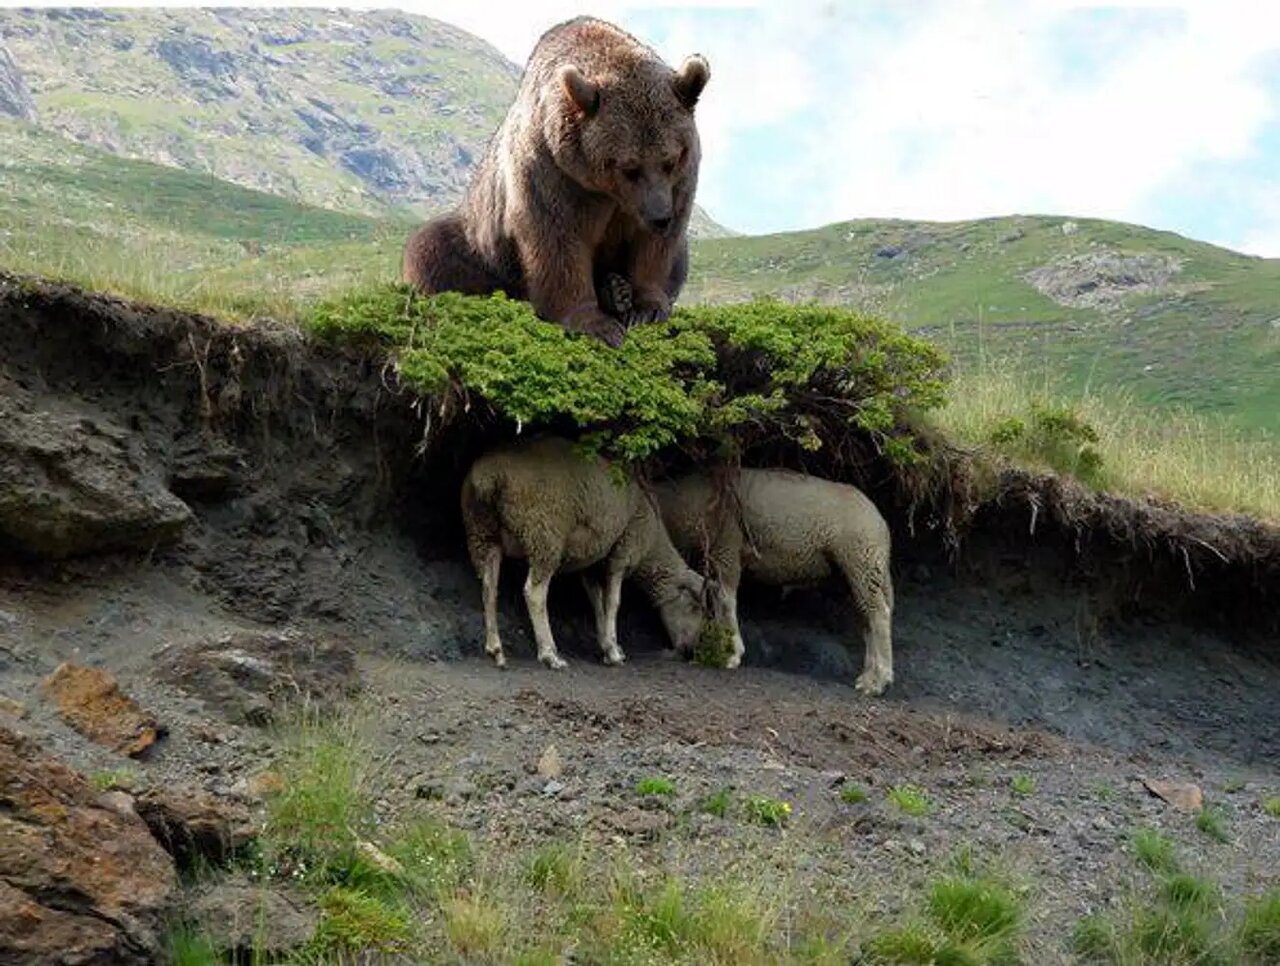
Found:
687,216 -> 1280,430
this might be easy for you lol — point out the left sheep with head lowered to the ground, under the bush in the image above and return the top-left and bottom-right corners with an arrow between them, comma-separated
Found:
462,436 -> 721,670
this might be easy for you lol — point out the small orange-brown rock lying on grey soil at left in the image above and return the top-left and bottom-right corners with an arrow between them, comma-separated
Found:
44,661 -> 165,757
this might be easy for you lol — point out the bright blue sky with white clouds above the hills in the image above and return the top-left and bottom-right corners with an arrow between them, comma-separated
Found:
17,0 -> 1280,257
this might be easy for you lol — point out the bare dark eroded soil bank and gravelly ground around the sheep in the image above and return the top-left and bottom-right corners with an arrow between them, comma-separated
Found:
0,275 -> 1280,951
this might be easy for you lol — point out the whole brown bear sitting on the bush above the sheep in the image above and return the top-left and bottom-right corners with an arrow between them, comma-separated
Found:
404,17 -> 710,347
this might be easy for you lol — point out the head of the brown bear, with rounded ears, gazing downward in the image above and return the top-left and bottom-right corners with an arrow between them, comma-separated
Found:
557,54 -> 710,234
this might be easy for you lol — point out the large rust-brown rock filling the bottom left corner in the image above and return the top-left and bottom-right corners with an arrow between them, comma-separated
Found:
0,728 -> 178,966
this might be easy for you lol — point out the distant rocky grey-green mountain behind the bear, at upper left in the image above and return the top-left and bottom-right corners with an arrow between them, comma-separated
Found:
0,9 -> 724,235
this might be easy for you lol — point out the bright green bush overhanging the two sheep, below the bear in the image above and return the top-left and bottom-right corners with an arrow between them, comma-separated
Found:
310,285 -> 946,462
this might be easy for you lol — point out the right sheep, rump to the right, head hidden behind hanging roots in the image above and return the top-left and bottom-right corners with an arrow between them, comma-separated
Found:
657,470 -> 893,695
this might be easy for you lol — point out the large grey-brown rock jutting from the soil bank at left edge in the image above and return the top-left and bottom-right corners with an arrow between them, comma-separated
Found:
0,376 -> 191,559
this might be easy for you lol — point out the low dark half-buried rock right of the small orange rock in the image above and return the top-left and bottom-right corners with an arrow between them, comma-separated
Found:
157,631 -> 360,724
